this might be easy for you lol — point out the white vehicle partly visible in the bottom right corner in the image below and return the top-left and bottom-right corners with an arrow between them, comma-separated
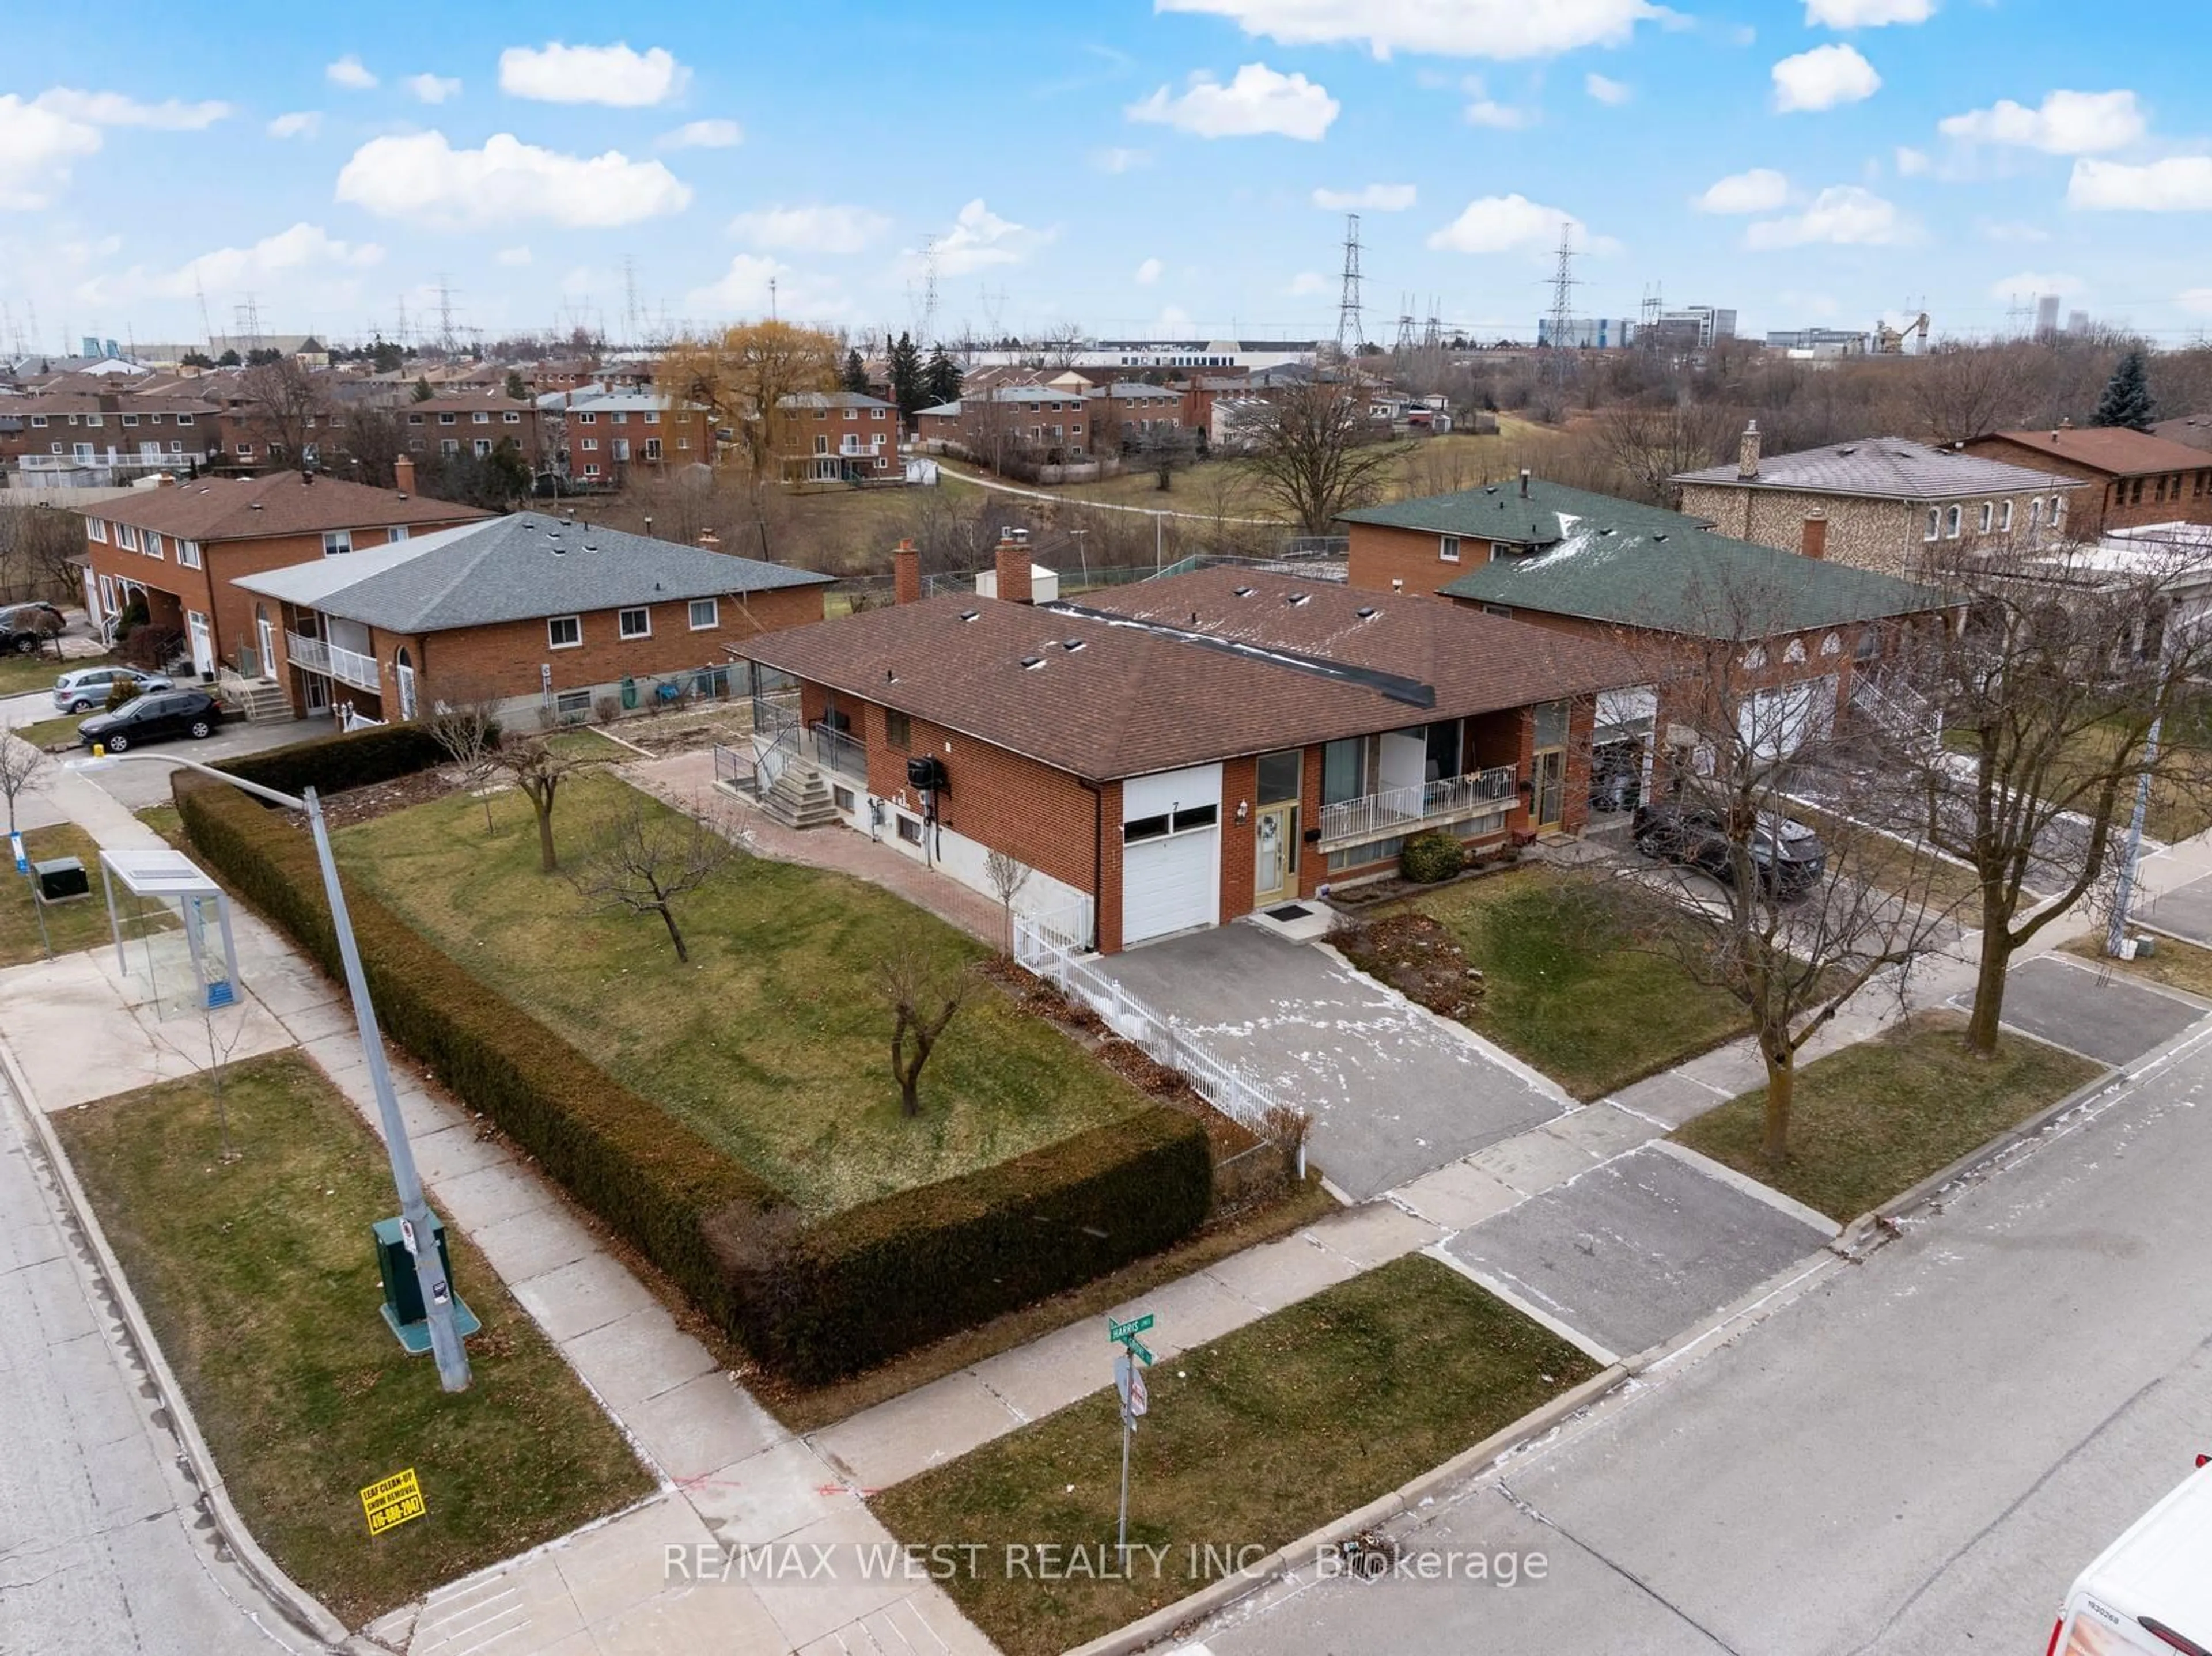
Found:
2046,1455 -> 2212,1656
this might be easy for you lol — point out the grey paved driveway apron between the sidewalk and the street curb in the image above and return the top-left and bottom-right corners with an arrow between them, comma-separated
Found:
1445,1145 -> 1834,1358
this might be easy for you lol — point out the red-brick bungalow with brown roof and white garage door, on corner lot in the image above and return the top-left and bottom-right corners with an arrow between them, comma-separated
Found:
732,546 -> 1637,953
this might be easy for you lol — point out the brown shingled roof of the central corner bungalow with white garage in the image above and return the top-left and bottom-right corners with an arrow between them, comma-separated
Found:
743,570 -> 1648,780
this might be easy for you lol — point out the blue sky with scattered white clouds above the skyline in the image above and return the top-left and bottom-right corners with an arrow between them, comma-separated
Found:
0,0 -> 2212,349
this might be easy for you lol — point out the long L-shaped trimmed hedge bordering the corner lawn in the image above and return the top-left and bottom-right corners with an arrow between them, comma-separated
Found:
173,774 -> 1212,1384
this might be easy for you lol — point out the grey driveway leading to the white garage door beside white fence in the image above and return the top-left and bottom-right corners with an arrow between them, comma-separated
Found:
1095,924 -> 1570,1200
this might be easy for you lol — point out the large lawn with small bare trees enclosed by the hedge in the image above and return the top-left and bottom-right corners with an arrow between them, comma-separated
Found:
336,774 -> 1143,1214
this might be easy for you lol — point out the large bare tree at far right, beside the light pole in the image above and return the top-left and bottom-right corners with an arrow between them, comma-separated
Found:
1878,544 -> 2212,1055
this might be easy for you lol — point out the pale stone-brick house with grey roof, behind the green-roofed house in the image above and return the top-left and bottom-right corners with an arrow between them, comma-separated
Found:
1668,425 -> 2086,575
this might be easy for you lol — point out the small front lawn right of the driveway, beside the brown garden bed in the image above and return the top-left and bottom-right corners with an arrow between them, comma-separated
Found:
1411,869 -> 1748,1099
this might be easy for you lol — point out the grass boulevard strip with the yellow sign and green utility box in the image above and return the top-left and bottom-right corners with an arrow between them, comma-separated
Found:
53,1055 -> 653,1627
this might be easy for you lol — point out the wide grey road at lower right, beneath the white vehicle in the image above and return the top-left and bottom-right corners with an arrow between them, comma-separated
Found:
1196,1013 -> 2212,1656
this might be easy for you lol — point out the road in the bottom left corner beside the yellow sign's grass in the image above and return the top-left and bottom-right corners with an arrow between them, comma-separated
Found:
0,1086 -> 314,1656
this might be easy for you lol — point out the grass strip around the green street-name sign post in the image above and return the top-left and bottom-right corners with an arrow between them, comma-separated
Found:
872,1253 -> 1597,1656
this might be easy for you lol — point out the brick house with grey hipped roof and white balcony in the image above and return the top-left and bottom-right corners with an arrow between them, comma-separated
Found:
239,513 -> 830,721
